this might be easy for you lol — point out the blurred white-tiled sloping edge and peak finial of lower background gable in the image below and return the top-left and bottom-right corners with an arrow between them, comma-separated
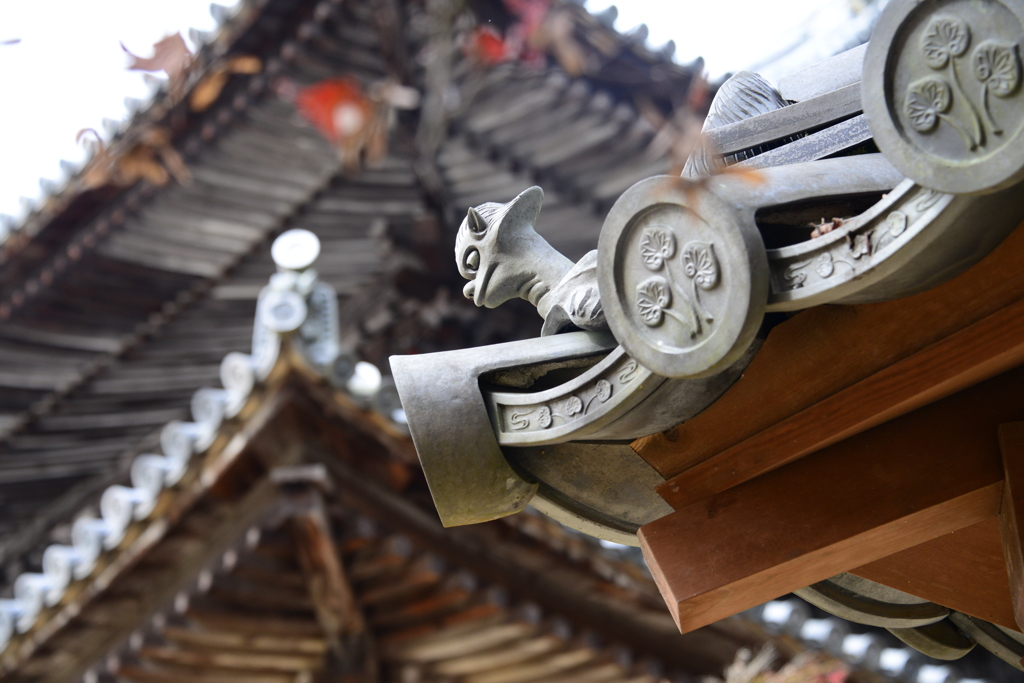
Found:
0,230 -> 415,676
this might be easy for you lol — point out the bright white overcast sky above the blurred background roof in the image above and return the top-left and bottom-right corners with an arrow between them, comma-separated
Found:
0,0 -> 858,223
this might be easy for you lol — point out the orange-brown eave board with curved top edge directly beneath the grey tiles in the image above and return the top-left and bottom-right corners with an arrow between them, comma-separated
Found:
633,222 -> 1024,508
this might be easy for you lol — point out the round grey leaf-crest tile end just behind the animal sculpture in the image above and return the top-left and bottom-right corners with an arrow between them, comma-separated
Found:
598,176 -> 768,378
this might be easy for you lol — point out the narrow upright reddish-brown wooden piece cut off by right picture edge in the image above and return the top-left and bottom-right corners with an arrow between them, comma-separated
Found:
999,422 -> 1024,631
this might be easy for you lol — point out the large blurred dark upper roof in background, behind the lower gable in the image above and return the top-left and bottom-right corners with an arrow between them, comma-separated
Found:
0,1 -> 704,558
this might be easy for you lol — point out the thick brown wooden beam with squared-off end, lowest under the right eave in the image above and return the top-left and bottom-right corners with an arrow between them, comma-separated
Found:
639,369 -> 1024,631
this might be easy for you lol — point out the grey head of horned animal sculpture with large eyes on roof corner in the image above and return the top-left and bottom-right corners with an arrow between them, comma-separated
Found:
455,187 -> 572,315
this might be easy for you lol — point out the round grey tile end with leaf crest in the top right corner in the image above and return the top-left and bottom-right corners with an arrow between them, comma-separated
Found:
861,0 -> 1024,195
